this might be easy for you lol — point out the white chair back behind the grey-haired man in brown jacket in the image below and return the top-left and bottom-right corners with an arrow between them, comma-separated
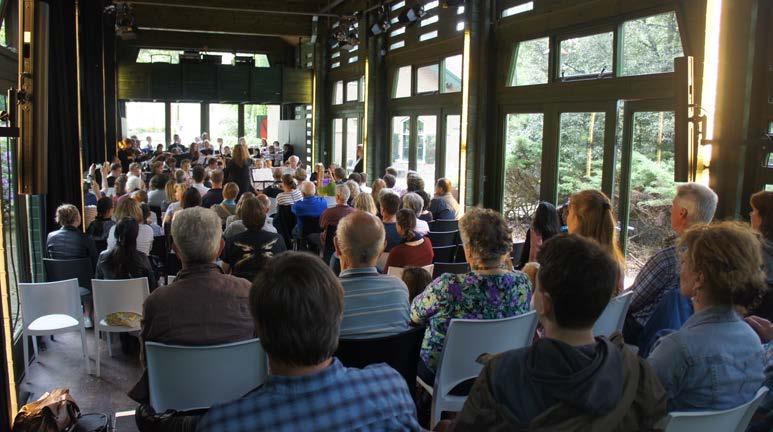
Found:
145,339 -> 268,413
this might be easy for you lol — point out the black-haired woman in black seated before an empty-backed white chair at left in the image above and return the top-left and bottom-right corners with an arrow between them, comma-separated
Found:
95,217 -> 158,292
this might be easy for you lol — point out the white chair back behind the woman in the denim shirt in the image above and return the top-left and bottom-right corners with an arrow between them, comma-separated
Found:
661,387 -> 768,432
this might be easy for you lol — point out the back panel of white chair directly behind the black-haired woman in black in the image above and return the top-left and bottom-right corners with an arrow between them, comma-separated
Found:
91,277 -> 150,331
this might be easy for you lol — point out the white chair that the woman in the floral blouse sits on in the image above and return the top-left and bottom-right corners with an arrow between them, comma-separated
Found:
417,311 -> 537,430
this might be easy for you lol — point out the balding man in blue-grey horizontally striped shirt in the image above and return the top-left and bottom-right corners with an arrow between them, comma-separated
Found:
335,211 -> 410,338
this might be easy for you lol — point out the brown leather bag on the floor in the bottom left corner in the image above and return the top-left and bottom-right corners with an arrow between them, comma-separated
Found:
13,388 -> 80,432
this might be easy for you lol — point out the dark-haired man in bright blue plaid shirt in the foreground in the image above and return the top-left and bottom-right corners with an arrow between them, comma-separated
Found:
197,252 -> 421,432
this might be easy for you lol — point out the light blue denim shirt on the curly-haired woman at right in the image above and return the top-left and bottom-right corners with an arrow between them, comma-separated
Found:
648,306 -> 765,411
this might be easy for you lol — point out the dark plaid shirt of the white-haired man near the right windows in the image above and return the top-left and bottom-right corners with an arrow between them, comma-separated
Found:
628,246 -> 679,326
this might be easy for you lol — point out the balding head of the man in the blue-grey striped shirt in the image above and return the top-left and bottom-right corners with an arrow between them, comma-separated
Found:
335,210 -> 385,267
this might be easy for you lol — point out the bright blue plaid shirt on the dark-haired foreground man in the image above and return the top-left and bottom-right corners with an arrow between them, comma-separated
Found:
197,359 -> 421,432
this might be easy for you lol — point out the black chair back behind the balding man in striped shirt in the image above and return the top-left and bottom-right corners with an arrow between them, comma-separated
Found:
335,327 -> 425,396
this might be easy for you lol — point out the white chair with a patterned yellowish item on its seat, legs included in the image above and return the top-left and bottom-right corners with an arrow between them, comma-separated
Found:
91,277 -> 150,376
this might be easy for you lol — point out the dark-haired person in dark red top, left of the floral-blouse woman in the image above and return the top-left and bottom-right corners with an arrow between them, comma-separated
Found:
384,209 -> 435,273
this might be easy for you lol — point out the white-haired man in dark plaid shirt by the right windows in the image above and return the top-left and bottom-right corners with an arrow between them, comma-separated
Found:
623,183 -> 717,343
